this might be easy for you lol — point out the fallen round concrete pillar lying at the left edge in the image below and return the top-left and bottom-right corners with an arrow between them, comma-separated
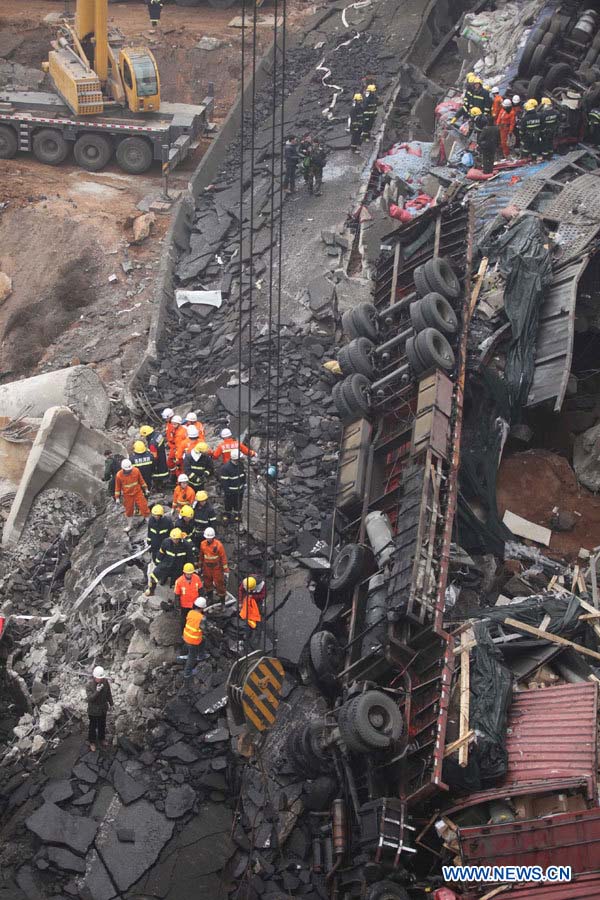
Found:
0,366 -> 110,428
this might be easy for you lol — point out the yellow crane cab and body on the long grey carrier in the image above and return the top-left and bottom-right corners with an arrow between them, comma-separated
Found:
44,0 -> 160,116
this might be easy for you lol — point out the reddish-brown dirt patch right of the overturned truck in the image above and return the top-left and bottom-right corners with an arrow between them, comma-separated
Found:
497,450 -> 600,560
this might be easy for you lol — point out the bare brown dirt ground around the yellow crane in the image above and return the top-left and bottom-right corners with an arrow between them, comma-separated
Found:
0,0 -> 314,396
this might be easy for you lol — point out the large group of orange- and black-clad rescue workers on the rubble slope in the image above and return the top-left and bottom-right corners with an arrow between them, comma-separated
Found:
104,407 -> 266,679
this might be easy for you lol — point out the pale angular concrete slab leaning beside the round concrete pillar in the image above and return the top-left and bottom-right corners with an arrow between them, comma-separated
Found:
2,408 -> 123,546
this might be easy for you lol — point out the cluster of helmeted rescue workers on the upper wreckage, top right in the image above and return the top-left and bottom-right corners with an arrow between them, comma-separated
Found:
462,72 -> 560,174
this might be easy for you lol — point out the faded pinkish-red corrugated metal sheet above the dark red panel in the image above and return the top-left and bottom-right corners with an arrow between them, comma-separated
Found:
446,682 -> 598,815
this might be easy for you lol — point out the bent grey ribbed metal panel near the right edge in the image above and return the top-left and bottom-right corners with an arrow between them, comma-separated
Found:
527,255 -> 589,412
